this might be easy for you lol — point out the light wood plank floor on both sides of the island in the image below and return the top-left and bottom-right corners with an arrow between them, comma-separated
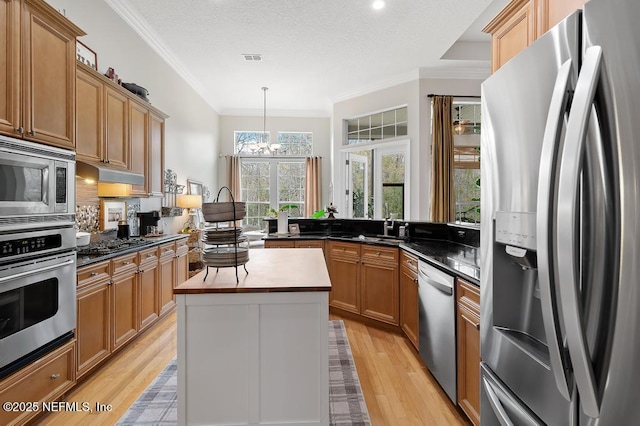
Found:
35,312 -> 470,426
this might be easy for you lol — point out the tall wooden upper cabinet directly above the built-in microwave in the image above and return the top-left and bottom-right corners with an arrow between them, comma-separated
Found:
0,0 -> 84,149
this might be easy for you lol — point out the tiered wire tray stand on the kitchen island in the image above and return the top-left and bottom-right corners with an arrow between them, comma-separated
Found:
202,186 -> 249,284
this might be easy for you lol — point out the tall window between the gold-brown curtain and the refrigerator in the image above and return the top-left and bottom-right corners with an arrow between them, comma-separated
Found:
453,102 -> 481,223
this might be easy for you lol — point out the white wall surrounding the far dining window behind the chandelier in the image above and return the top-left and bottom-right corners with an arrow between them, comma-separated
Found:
219,114 -> 331,206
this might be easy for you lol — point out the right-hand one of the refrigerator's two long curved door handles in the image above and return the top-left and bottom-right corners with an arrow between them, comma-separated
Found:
556,46 -> 602,418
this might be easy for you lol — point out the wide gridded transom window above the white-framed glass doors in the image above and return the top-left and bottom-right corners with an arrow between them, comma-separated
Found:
346,107 -> 407,145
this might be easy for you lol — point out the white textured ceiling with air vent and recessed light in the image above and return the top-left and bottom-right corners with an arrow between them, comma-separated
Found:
107,0 -> 506,116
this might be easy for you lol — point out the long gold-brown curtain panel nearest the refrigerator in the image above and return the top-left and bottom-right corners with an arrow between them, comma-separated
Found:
431,96 -> 455,222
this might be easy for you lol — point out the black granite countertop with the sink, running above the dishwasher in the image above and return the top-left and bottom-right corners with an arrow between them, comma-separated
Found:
263,233 -> 480,286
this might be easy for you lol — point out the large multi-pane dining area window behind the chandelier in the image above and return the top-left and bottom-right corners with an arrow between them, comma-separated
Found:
235,132 -> 313,229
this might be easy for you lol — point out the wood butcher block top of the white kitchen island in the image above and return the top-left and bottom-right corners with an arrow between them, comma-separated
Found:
173,248 -> 331,294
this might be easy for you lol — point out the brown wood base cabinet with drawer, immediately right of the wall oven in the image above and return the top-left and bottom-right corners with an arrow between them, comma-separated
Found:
76,261 -> 111,378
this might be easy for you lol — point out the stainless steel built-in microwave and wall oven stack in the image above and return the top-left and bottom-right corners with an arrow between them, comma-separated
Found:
0,136 -> 76,378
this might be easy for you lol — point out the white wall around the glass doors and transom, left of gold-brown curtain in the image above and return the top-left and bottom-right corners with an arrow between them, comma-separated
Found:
332,78 -> 482,221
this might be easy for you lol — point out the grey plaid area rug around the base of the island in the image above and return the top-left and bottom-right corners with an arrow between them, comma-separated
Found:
118,321 -> 371,426
